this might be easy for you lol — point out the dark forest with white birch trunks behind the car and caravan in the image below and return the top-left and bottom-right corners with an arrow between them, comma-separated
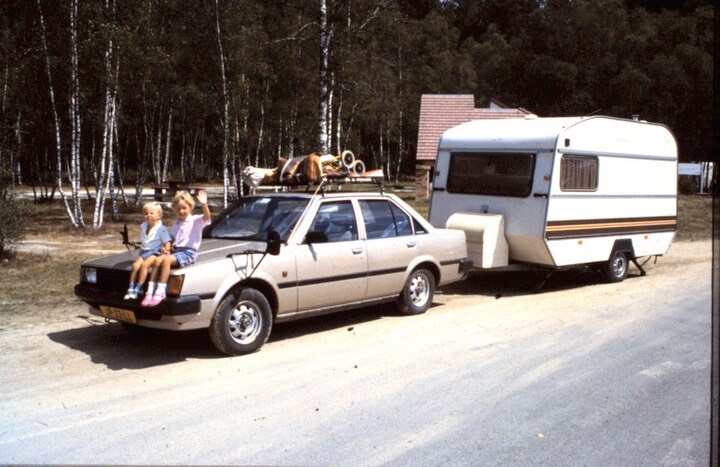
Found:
0,0 -> 714,229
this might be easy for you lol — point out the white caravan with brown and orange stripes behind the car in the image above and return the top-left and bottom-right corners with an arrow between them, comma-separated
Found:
429,115 -> 677,281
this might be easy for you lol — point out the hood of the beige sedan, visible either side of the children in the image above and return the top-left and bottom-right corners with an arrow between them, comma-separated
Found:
83,238 -> 266,271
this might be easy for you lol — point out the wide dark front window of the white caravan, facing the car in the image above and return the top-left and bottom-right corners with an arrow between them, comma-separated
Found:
447,153 -> 535,198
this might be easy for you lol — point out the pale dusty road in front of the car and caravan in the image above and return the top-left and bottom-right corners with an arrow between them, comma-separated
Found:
0,241 -> 711,466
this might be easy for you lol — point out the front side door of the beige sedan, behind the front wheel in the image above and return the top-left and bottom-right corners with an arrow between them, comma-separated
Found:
296,200 -> 367,311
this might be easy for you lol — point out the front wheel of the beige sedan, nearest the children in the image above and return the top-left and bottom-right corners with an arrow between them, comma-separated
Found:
209,288 -> 272,356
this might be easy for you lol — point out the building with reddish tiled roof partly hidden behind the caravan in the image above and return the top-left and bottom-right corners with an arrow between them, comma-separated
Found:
415,94 -> 530,198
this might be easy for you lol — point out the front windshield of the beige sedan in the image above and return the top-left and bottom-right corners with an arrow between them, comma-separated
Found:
208,196 -> 309,242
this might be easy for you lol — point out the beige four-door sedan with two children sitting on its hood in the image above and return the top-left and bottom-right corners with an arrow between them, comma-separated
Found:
75,192 -> 472,355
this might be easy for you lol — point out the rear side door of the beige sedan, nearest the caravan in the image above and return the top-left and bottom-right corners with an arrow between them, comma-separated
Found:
359,199 -> 418,298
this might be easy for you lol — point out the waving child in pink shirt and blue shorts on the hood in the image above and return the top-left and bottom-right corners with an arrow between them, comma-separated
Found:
142,190 -> 210,306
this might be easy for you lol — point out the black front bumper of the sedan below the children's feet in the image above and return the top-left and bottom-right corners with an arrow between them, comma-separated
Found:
75,283 -> 202,320
